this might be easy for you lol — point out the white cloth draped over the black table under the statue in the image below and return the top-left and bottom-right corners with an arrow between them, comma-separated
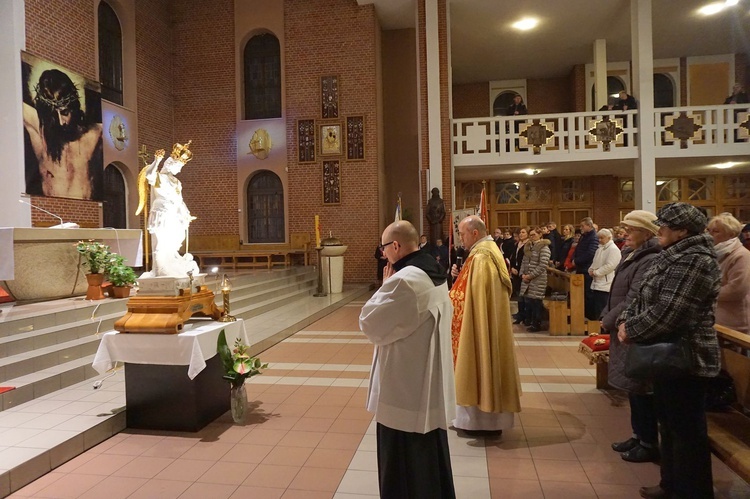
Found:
91,319 -> 250,379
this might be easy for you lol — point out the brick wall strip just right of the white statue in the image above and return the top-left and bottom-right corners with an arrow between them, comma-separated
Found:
172,0 -> 239,235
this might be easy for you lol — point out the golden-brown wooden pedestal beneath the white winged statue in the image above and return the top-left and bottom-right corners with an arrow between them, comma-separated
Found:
115,274 -> 221,334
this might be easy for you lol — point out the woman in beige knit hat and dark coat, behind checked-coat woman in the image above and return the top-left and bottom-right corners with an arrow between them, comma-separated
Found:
602,210 -> 661,463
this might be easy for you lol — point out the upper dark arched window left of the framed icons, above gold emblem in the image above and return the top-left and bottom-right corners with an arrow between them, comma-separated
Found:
243,33 -> 281,120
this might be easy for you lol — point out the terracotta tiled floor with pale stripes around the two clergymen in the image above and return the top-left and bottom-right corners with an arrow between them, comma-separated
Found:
5,301 -> 750,499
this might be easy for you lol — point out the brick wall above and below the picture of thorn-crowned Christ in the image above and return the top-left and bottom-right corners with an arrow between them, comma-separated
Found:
24,0 -> 101,227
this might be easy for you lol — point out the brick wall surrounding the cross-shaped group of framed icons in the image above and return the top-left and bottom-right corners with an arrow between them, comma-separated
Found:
283,0 -> 381,282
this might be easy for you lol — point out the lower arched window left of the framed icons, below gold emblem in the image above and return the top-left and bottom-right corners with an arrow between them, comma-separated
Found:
247,171 -> 285,243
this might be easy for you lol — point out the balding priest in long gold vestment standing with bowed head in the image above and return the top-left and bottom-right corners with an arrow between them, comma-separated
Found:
450,215 -> 521,434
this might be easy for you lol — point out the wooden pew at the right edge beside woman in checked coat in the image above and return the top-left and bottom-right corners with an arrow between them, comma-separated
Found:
706,324 -> 750,482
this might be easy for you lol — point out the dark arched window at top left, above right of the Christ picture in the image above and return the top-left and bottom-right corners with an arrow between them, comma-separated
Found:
98,2 -> 123,106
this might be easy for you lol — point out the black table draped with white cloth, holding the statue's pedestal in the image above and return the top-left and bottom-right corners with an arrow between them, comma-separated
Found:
92,319 -> 249,431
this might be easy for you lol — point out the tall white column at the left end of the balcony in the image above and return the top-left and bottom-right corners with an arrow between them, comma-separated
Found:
424,0 -> 444,193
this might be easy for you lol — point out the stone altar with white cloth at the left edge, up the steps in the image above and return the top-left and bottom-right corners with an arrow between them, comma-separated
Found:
0,227 -> 143,301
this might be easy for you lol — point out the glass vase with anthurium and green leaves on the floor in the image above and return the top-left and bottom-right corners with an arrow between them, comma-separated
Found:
216,329 -> 268,423
